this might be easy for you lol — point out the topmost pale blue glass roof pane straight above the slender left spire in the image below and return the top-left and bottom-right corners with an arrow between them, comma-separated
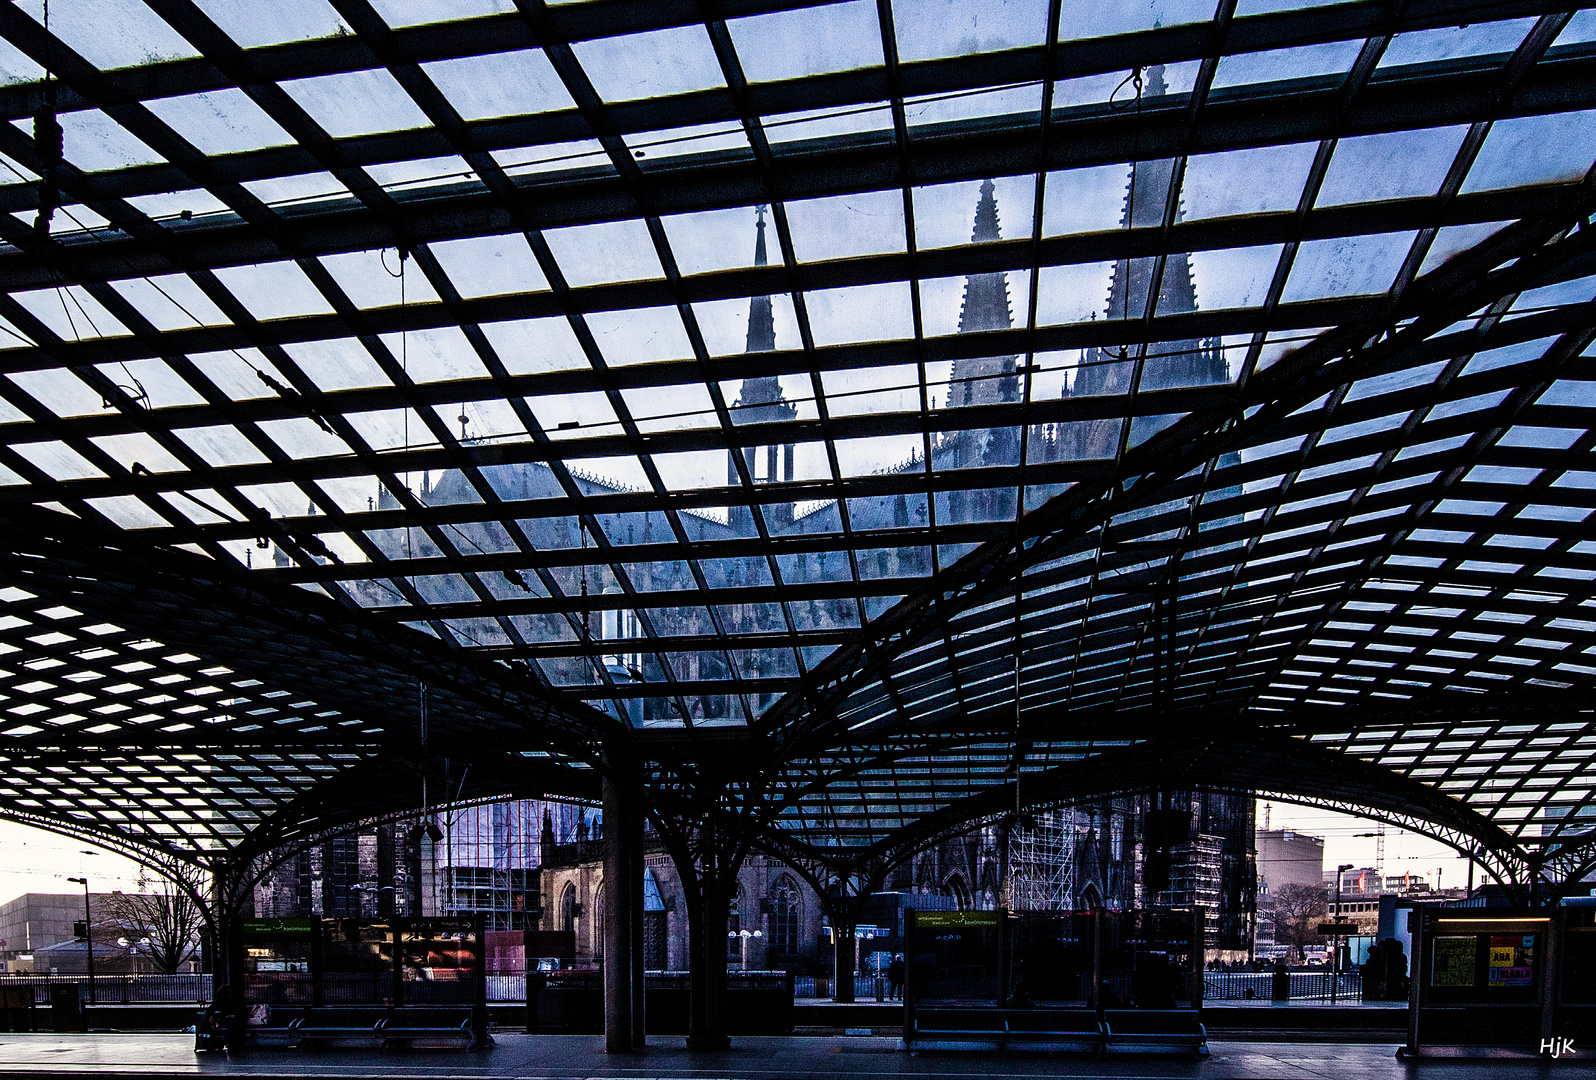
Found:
726,0 -> 884,83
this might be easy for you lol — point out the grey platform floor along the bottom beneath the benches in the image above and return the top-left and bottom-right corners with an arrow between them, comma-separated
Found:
0,1034 -> 1596,1080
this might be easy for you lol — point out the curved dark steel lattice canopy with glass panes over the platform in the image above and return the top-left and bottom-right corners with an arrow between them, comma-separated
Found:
0,0 -> 1596,880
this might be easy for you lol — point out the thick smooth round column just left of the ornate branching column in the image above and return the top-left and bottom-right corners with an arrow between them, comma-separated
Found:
603,753 -> 642,1054
